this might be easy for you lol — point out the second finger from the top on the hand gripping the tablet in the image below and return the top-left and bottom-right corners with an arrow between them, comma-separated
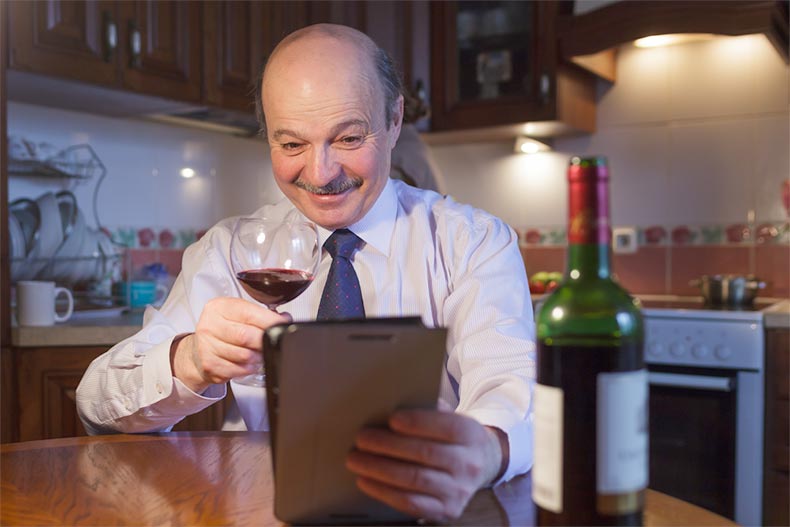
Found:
355,428 -> 458,472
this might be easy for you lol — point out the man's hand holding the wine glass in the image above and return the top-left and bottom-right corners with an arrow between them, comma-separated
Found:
170,298 -> 291,393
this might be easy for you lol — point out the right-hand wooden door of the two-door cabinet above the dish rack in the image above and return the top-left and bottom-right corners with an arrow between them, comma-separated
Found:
119,0 -> 202,102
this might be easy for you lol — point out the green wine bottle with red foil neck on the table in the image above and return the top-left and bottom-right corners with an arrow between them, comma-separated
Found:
532,157 -> 648,525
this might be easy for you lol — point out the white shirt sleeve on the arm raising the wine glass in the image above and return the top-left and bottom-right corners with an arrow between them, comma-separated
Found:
76,226 -> 237,434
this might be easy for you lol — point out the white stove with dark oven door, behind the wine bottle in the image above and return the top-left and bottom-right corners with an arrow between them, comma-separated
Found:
642,299 -> 766,525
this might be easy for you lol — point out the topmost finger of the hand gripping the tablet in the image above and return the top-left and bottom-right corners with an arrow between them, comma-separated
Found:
389,410 -> 485,445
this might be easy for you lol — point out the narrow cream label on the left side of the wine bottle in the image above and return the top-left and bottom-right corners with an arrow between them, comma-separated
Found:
532,384 -> 564,513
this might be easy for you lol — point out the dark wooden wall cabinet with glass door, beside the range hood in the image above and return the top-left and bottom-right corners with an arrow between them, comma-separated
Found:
430,1 -> 595,135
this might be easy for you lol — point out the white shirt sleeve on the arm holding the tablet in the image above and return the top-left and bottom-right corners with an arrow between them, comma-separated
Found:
444,210 -> 536,483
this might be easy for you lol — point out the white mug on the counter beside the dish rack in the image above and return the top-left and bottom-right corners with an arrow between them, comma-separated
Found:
16,280 -> 74,326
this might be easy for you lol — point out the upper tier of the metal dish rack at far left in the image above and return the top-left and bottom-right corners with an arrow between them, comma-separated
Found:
8,144 -> 107,179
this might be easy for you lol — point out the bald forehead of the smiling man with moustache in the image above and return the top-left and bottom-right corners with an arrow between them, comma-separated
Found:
262,35 -> 383,132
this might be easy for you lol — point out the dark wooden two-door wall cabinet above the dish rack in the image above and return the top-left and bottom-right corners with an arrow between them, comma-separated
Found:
8,0 -> 201,102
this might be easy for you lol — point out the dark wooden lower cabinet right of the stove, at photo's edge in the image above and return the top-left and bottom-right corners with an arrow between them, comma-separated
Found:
763,328 -> 790,525
